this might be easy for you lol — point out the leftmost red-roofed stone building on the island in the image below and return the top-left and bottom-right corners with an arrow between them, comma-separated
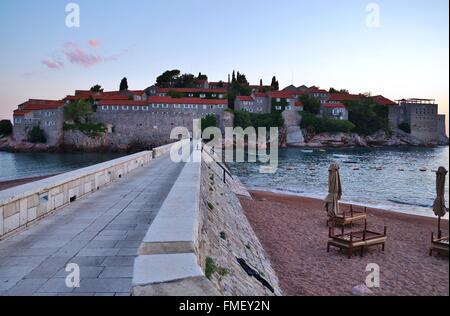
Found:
13,99 -> 64,146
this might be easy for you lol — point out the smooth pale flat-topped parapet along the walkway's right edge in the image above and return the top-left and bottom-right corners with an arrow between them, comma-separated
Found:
133,146 -> 218,296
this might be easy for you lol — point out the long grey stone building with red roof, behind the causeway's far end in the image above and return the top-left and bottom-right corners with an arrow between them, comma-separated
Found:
94,96 -> 228,146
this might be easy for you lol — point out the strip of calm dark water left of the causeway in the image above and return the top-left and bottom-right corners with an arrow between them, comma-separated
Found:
0,152 -> 123,181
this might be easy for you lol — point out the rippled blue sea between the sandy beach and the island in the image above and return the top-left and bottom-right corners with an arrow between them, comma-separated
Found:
231,147 -> 449,216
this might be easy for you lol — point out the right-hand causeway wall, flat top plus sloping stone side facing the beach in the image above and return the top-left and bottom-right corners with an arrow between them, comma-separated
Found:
133,146 -> 281,296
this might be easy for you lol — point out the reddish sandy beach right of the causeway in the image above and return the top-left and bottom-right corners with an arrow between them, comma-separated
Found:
241,192 -> 449,296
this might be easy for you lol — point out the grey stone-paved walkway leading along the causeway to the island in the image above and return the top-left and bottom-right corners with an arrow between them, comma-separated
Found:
0,157 -> 183,296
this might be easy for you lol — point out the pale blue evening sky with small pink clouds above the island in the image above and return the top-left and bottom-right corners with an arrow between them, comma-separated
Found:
0,0 -> 449,132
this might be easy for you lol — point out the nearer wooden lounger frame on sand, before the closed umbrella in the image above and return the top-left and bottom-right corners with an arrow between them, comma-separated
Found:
327,221 -> 387,259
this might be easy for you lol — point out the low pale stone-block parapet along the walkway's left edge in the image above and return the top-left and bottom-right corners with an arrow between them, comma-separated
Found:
0,151 -> 153,239
